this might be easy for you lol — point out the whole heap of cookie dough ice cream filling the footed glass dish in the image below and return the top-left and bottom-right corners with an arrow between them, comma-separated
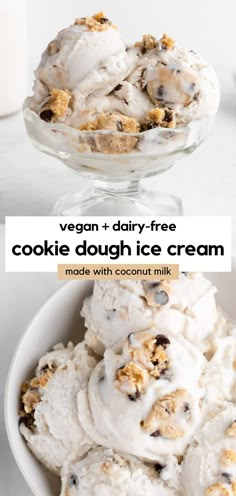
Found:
26,12 -> 220,154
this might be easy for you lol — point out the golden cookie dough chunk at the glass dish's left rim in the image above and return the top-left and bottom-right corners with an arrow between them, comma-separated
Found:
39,89 -> 71,122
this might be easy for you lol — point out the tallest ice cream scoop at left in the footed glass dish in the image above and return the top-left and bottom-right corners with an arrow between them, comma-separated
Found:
28,13 -> 135,127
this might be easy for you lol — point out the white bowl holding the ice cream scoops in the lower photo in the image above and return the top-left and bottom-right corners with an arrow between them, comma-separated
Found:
5,272 -> 236,496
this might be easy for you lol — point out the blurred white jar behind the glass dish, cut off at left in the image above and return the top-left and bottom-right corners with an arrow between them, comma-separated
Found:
0,0 -> 28,117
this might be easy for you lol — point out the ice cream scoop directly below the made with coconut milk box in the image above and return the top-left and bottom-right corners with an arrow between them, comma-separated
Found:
81,280 -> 153,355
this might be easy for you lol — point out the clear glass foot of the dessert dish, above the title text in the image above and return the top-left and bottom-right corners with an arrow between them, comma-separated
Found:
52,181 -> 183,216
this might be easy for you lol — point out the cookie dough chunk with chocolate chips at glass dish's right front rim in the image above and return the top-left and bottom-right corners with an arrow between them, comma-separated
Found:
140,107 -> 176,132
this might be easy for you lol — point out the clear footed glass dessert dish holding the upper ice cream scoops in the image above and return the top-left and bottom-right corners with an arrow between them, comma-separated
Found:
24,105 -> 214,216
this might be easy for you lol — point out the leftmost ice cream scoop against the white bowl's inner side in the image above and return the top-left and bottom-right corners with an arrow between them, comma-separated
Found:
20,343 -> 96,474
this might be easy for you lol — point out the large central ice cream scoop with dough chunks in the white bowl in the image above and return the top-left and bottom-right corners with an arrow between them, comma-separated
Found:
78,329 -> 205,463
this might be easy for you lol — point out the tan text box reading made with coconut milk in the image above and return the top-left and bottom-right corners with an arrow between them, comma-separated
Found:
57,264 -> 179,281
